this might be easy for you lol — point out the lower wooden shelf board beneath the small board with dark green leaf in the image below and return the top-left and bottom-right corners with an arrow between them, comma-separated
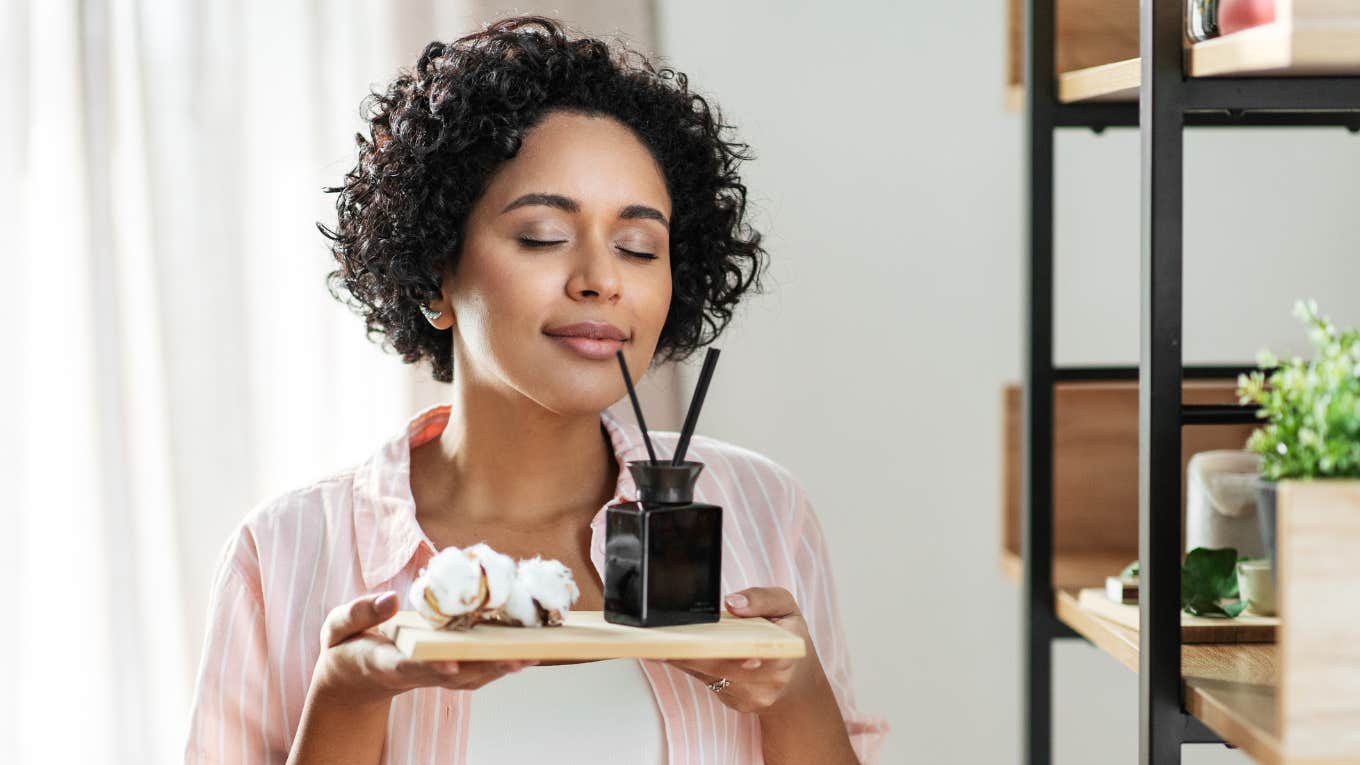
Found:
1055,589 -> 1287,765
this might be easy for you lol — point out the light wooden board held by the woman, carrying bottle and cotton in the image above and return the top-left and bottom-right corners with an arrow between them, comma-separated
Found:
378,611 -> 806,662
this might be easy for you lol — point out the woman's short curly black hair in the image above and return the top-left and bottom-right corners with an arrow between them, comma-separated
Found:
317,16 -> 767,383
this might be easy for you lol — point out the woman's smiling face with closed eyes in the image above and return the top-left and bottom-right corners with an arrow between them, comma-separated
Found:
435,112 -> 670,414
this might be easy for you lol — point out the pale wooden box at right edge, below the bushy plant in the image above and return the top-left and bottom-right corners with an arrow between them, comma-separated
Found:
1276,481 -> 1360,762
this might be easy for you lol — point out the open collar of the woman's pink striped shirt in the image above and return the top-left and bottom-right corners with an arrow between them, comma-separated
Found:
354,404 -> 646,592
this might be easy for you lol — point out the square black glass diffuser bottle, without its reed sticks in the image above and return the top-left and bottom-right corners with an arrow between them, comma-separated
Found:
604,460 -> 722,628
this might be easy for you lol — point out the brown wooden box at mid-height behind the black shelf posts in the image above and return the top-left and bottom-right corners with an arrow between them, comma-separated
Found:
1001,380 -> 1253,589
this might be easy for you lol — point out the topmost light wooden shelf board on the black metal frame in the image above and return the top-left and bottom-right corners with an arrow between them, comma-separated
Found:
1058,22 -> 1360,103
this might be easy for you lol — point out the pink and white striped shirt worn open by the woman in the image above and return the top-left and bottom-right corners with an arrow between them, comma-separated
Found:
185,404 -> 888,765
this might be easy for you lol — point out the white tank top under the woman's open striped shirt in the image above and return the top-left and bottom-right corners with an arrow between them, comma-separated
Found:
468,659 -> 666,765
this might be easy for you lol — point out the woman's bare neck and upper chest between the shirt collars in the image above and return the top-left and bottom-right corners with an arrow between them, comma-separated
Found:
412,376 -> 619,530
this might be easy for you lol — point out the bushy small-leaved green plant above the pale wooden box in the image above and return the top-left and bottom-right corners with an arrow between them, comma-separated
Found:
1238,301 -> 1360,481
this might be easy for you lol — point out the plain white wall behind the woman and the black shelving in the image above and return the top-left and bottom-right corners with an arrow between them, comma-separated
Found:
660,0 -> 1360,764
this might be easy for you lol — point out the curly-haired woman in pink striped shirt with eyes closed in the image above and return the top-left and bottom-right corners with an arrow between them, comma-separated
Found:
188,16 -> 887,764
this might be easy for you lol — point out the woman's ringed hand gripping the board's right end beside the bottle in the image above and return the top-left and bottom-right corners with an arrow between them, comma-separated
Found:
666,587 -> 821,715
